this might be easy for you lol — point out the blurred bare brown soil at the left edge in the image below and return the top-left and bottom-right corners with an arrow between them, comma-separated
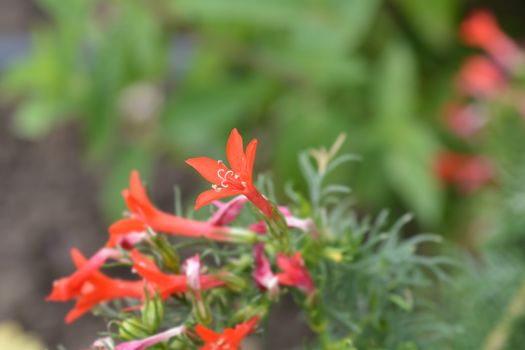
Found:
0,111 -> 105,349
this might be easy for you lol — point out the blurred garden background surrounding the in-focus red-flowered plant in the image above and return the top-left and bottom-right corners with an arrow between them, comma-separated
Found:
0,0 -> 525,350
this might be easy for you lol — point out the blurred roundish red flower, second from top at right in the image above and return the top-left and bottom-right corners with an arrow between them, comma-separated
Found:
458,56 -> 505,98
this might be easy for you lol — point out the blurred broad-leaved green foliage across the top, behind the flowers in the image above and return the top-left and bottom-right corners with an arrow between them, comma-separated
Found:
3,0 -> 458,225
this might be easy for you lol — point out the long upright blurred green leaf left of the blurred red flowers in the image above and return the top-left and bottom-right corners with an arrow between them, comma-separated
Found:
374,40 -> 442,224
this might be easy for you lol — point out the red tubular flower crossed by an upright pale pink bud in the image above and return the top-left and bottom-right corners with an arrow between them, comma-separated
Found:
131,250 -> 224,298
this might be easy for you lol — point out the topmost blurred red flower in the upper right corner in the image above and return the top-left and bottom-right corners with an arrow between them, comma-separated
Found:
461,10 -> 520,68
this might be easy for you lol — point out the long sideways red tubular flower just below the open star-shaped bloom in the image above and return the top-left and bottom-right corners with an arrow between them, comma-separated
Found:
106,170 -> 250,243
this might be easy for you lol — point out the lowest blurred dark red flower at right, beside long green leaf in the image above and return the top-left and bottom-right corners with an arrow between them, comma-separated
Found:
435,152 -> 495,193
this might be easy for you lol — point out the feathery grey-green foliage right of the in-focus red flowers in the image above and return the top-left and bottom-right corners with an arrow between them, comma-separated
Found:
292,149 -> 455,349
